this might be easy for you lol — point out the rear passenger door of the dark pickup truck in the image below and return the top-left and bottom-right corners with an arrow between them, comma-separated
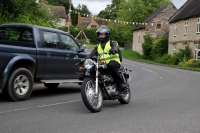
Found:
38,31 -> 64,79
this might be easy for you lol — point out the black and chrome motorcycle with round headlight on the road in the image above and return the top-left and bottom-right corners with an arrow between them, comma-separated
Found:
77,52 -> 132,113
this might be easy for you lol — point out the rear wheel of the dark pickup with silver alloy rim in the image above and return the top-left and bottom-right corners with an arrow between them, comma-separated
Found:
3,68 -> 33,101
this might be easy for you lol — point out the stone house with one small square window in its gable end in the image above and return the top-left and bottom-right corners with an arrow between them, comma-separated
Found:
132,2 -> 177,54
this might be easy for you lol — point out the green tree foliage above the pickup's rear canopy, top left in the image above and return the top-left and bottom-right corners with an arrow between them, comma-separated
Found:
0,0 -> 53,27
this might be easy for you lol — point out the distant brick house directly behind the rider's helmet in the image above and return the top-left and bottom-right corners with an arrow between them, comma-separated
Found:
77,15 -> 108,29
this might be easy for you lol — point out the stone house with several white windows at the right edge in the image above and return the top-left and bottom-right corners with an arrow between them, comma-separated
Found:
168,0 -> 200,58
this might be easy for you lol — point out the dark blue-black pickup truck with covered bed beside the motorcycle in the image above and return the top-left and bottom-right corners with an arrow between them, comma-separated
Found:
0,23 -> 88,101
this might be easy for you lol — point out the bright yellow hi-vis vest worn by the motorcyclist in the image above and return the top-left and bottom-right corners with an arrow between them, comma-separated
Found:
97,41 -> 121,64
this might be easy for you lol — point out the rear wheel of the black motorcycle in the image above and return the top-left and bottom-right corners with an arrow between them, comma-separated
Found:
118,84 -> 131,104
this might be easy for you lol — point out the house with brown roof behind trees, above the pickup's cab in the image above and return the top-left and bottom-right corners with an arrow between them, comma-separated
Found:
40,1 -> 71,27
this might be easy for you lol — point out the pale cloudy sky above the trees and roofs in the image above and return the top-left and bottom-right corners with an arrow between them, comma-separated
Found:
72,0 -> 187,15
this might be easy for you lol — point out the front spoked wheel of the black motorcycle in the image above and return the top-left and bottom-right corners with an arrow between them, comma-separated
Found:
81,78 -> 103,113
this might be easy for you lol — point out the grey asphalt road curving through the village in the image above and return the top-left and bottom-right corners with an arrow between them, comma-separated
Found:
0,59 -> 200,133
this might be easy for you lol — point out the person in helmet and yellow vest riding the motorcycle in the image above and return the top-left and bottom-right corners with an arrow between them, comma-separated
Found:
86,26 -> 127,90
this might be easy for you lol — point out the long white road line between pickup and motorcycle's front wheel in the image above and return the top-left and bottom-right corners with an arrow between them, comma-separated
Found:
0,99 -> 82,114
